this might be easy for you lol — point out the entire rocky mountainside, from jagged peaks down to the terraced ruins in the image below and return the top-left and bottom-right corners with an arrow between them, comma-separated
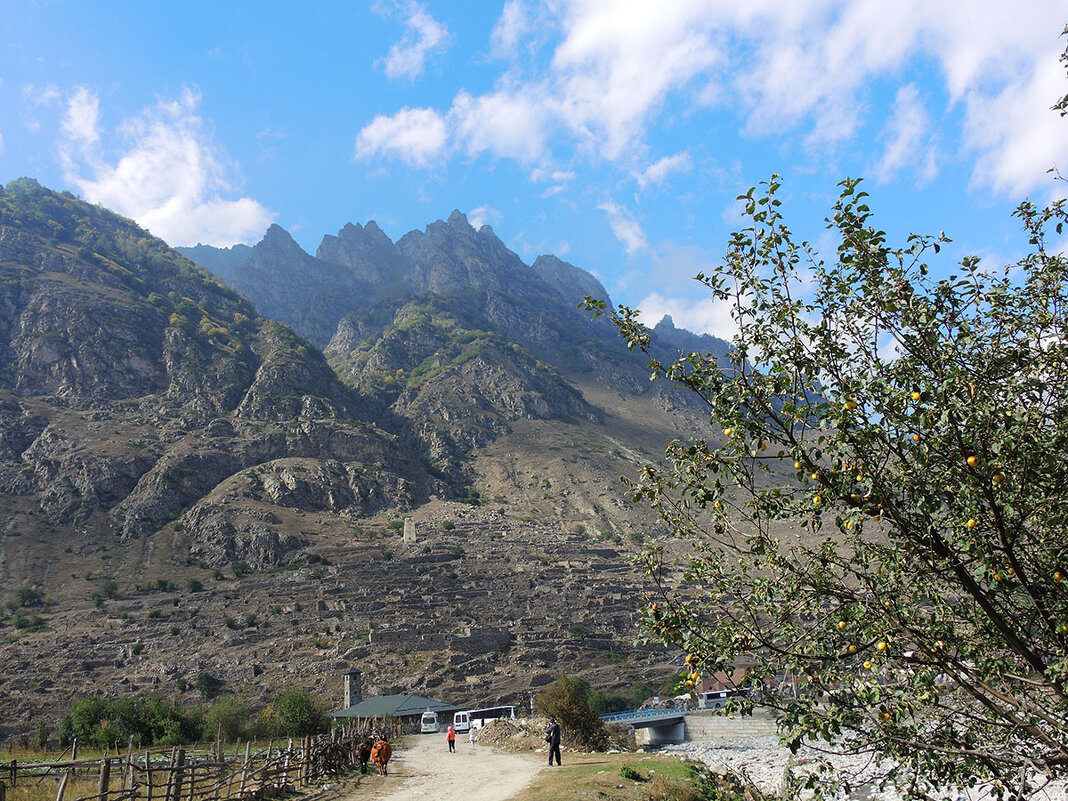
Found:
0,180 -> 726,735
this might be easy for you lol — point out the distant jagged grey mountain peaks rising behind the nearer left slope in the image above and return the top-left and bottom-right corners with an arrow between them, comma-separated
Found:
186,210 -> 726,476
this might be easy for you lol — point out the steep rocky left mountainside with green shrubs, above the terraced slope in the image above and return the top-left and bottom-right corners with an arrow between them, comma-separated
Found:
0,180 -> 433,564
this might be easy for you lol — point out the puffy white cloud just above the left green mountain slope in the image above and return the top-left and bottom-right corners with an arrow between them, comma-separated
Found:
61,88 -> 274,246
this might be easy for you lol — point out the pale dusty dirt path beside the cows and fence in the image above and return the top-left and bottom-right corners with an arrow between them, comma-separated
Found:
360,733 -> 545,801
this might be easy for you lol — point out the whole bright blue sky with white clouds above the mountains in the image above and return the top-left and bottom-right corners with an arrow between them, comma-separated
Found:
0,0 -> 1068,334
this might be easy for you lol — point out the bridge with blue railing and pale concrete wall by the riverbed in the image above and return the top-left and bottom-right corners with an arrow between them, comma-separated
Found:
600,709 -> 775,745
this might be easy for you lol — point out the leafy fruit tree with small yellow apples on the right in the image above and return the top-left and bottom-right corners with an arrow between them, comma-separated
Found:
585,177 -> 1068,798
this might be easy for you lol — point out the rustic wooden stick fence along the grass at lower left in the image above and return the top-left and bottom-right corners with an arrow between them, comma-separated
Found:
0,726 -> 384,801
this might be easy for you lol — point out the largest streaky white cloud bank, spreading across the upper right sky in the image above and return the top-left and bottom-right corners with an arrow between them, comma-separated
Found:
361,0 -> 1068,200
